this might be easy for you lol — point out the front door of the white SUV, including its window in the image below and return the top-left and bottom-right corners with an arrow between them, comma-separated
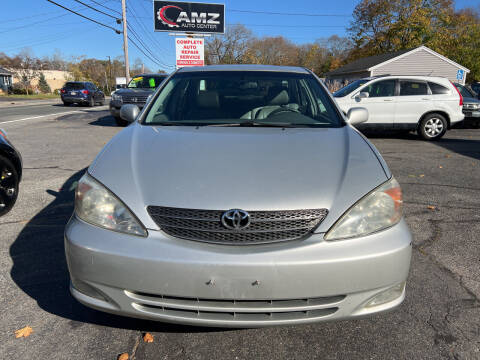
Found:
352,79 -> 396,128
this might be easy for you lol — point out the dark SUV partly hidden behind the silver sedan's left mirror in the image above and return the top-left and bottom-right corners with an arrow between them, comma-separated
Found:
110,74 -> 167,126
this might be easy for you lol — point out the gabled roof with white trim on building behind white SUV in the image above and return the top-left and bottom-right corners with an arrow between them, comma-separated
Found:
327,45 -> 470,76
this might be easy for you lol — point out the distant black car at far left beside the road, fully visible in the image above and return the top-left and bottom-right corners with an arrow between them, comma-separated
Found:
60,81 -> 105,106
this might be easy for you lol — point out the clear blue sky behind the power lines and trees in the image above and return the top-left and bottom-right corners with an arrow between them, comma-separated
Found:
0,0 -> 479,72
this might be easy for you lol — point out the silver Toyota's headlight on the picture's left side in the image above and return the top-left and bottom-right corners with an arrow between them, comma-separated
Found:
75,174 -> 147,236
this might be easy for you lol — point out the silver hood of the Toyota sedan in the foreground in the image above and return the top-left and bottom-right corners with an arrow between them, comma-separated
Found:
89,123 -> 390,232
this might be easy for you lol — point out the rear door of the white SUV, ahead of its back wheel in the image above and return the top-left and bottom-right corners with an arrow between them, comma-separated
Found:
395,79 -> 435,129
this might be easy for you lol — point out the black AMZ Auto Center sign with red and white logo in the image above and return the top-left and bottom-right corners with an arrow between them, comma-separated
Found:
153,0 -> 225,34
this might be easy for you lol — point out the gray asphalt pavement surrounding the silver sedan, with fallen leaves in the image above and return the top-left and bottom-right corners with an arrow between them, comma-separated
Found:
0,106 -> 480,360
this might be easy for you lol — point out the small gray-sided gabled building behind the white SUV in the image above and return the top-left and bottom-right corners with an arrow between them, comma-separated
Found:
326,46 -> 470,88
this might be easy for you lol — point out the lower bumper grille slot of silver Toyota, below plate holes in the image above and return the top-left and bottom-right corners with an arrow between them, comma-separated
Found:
125,290 -> 346,322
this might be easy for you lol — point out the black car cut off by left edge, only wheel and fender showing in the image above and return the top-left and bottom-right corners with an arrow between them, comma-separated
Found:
0,129 -> 22,216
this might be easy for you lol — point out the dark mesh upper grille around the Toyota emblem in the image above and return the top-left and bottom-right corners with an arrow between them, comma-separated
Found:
147,206 -> 327,245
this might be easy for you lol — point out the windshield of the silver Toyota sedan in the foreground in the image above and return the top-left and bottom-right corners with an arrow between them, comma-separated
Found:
143,71 -> 343,127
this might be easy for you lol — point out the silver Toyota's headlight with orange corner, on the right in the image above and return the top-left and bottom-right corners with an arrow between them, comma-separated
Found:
325,177 -> 403,240
